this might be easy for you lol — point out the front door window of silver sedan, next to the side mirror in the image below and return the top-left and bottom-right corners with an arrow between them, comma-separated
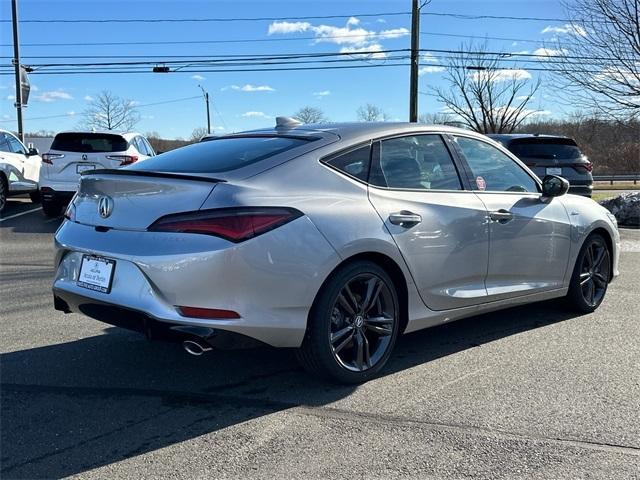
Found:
454,137 -> 538,193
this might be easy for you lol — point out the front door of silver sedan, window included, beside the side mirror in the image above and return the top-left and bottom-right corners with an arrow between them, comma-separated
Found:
454,136 -> 571,300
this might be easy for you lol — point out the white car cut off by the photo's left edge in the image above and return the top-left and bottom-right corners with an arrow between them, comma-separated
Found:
0,130 -> 42,212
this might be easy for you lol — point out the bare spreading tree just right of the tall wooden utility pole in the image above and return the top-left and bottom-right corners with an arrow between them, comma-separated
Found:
430,44 -> 540,133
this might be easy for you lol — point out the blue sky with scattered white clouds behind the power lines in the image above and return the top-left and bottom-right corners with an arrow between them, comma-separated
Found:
0,0 -> 568,138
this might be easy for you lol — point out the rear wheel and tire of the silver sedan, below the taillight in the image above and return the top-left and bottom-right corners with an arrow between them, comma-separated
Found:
297,261 -> 400,384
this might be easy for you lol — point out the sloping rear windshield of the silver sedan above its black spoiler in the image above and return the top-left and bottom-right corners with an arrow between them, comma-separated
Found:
128,136 -> 316,173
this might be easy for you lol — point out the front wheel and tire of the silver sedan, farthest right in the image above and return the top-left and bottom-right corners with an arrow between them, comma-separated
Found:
566,233 -> 611,313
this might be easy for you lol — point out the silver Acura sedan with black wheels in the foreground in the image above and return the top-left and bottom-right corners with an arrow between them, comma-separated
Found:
53,118 -> 619,383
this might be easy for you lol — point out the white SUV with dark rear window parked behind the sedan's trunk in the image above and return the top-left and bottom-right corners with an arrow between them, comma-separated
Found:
40,131 -> 155,217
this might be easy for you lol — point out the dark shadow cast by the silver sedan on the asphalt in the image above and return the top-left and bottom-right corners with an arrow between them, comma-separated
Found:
0,301 -> 576,478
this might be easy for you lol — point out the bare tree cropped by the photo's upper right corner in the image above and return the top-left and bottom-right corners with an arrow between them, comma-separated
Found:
547,0 -> 640,118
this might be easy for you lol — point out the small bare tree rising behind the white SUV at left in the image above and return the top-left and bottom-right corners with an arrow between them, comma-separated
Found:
82,90 -> 140,130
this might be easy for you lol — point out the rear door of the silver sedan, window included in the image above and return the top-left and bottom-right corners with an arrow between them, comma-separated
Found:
369,134 -> 489,310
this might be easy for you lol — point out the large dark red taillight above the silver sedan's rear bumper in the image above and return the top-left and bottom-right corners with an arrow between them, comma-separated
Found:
148,207 -> 302,243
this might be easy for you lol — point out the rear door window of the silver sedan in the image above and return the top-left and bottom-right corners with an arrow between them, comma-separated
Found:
370,135 -> 462,190
